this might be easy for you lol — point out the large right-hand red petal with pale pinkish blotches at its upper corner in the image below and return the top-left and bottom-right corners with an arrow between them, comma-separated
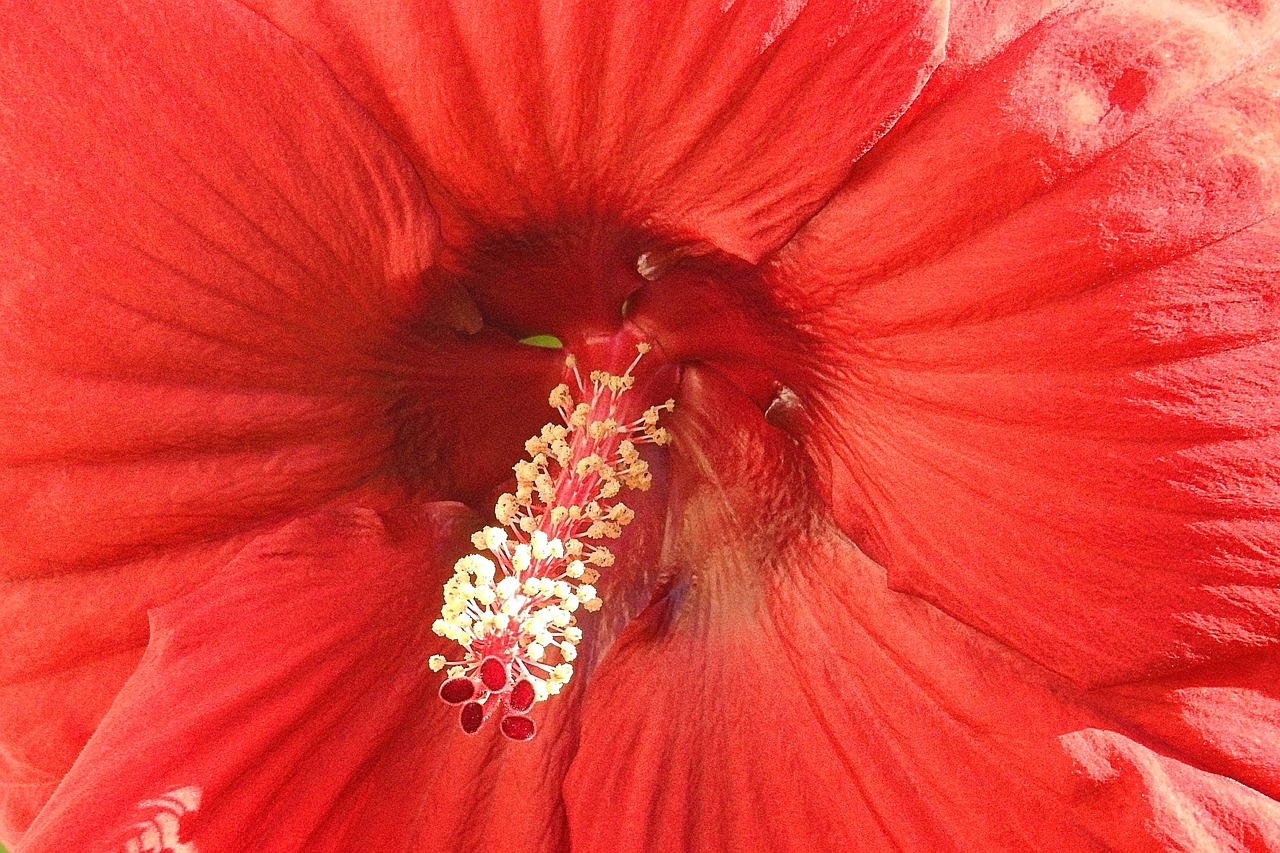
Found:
774,4 -> 1280,684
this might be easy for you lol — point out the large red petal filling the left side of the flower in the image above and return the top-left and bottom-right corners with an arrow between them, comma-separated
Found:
0,1 -> 483,835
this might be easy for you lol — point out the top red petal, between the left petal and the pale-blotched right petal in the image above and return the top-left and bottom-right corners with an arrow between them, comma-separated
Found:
240,0 -> 946,259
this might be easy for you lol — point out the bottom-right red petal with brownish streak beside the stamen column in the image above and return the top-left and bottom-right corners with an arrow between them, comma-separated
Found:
564,373 -> 1280,852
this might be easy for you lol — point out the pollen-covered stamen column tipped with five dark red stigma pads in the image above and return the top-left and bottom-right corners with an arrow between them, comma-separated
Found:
428,343 -> 675,740
